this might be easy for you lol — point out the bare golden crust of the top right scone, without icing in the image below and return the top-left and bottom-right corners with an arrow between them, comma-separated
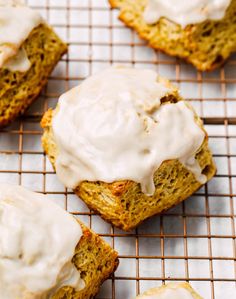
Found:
109,0 -> 236,71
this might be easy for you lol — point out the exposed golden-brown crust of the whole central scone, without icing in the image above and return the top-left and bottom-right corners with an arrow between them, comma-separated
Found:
41,89 -> 216,231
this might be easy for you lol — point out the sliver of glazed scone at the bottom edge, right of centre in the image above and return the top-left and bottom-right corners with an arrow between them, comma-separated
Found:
136,282 -> 203,299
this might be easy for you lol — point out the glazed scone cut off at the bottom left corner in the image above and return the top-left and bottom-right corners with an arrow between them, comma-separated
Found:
0,184 -> 118,299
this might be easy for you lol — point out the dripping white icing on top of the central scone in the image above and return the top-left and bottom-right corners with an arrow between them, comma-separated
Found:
52,68 -> 206,195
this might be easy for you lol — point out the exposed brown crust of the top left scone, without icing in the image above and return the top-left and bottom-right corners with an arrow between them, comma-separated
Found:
0,24 -> 67,127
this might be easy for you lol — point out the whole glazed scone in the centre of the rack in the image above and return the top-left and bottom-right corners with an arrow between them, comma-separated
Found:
41,67 -> 216,230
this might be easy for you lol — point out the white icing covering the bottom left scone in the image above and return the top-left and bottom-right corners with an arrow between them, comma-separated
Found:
0,184 -> 84,299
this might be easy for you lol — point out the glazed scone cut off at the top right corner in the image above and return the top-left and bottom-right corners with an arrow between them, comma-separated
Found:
109,0 -> 236,71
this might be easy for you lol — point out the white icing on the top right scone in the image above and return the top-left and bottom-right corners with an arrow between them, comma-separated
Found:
144,0 -> 231,27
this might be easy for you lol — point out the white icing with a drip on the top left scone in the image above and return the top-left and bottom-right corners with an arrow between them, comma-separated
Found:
0,0 -> 42,71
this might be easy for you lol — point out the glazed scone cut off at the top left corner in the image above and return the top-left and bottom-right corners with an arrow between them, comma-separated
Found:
0,0 -> 67,127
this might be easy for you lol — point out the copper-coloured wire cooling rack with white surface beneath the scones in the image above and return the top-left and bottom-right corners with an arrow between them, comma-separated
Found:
0,0 -> 236,299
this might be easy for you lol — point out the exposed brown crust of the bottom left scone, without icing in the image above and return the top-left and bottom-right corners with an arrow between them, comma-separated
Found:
53,222 -> 119,299
